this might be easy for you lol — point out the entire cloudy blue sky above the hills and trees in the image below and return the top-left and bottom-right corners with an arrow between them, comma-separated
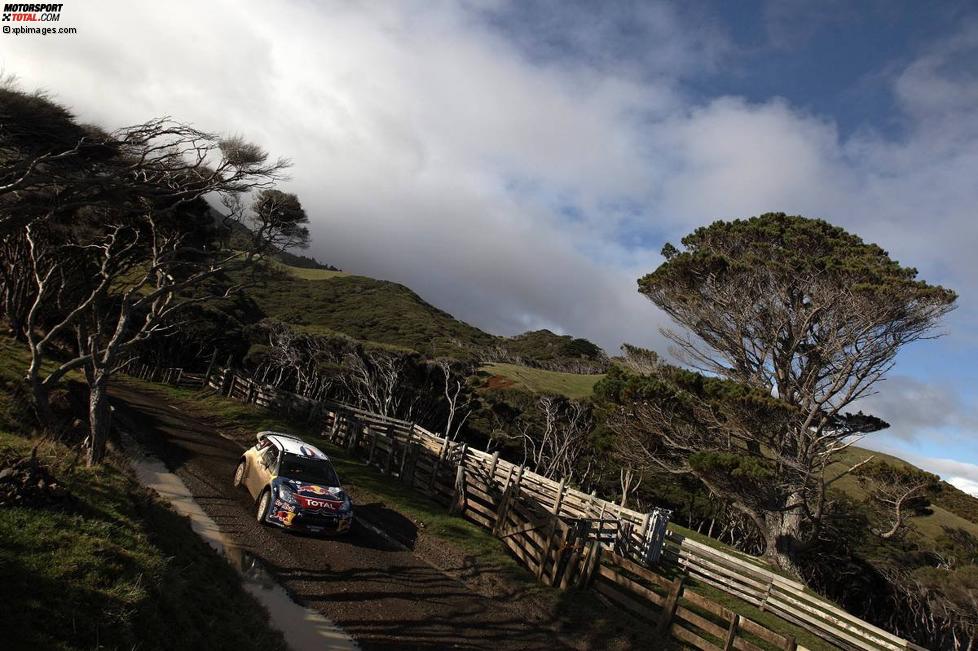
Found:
0,0 -> 978,494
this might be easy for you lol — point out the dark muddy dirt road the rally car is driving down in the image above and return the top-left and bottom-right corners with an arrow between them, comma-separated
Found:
112,386 -> 568,651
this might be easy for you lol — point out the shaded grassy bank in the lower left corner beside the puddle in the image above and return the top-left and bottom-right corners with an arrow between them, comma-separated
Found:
0,432 -> 285,649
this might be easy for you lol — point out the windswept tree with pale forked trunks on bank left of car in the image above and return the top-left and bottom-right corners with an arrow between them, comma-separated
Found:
9,119 -> 287,463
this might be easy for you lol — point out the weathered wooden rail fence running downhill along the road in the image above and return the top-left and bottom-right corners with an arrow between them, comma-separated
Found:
126,363 -> 927,651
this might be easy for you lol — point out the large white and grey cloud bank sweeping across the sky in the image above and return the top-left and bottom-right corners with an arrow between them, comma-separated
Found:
0,0 -> 978,382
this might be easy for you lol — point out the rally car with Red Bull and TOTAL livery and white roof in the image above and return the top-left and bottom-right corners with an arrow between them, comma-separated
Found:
234,432 -> 353,533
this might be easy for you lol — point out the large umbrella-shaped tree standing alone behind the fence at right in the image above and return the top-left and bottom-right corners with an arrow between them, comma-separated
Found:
619,213 -> 956,571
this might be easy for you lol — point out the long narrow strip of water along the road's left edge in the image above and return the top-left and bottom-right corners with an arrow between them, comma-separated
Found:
127,442 -> 358,651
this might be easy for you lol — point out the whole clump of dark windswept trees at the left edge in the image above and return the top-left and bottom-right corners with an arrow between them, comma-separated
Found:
0,84 -> 309,463
